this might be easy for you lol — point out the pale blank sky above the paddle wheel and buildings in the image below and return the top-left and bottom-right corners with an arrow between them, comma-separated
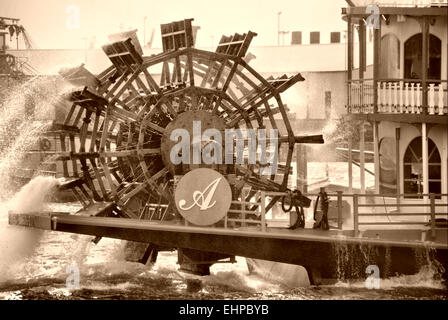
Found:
0,0 -> 347,49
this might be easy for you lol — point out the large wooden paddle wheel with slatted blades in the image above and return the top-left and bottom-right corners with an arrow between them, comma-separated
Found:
52,19 -> 323,276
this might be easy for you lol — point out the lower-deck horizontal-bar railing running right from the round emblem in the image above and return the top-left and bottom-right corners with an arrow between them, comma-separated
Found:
172,190 -> 448,235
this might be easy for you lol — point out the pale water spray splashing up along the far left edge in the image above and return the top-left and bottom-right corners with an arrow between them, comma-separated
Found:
0,77 -> 68,282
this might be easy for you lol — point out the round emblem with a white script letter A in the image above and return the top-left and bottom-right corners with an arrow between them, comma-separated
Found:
174,168 -> 232,226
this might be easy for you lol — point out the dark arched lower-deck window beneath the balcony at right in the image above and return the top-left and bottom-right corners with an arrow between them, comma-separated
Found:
403,137 -> 442,197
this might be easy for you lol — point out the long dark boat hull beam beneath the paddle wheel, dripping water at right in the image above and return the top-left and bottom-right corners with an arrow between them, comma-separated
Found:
9,213 -> 448,284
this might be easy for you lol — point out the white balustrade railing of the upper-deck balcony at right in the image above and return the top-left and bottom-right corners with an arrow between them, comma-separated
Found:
347,79 -> 448,115
